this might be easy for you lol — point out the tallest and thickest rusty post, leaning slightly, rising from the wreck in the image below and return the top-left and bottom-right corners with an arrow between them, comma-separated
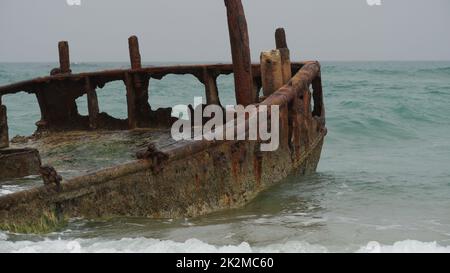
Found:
225,0 -> 256,106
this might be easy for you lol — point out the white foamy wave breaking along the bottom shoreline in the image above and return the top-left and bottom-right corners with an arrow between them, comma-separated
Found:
0,233 -> 450,253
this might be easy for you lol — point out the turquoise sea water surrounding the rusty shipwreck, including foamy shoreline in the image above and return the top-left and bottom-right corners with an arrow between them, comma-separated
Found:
0,62 -> 450,252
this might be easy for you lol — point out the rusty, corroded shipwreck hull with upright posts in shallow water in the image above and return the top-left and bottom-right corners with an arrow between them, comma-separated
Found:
0,0 -> 327,232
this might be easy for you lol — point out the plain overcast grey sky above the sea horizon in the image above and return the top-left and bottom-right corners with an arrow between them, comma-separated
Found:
0,0 -> 450,62
